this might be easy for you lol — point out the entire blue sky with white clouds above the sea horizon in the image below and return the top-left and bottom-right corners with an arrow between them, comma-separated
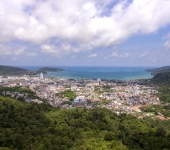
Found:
0,0 -> 170,66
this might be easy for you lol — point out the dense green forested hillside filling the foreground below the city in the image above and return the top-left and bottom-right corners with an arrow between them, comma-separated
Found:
0,96 -> 170,150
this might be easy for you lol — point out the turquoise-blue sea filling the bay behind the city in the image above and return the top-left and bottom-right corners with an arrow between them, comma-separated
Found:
18,66 -> 155,80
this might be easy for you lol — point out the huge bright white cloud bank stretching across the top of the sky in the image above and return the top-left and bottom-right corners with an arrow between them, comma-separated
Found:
0,0 -> 170,55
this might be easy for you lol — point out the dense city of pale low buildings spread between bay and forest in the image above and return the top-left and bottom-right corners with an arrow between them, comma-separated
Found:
0,73 -> 165,120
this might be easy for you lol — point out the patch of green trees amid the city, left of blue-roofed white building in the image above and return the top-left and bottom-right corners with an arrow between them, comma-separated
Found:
56,90 -> 76,101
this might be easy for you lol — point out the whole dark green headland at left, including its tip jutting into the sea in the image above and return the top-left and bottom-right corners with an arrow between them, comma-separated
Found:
0,65 -> 64,76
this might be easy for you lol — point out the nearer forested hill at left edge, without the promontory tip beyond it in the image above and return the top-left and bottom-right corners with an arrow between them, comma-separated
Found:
0,65 -> 37,75
